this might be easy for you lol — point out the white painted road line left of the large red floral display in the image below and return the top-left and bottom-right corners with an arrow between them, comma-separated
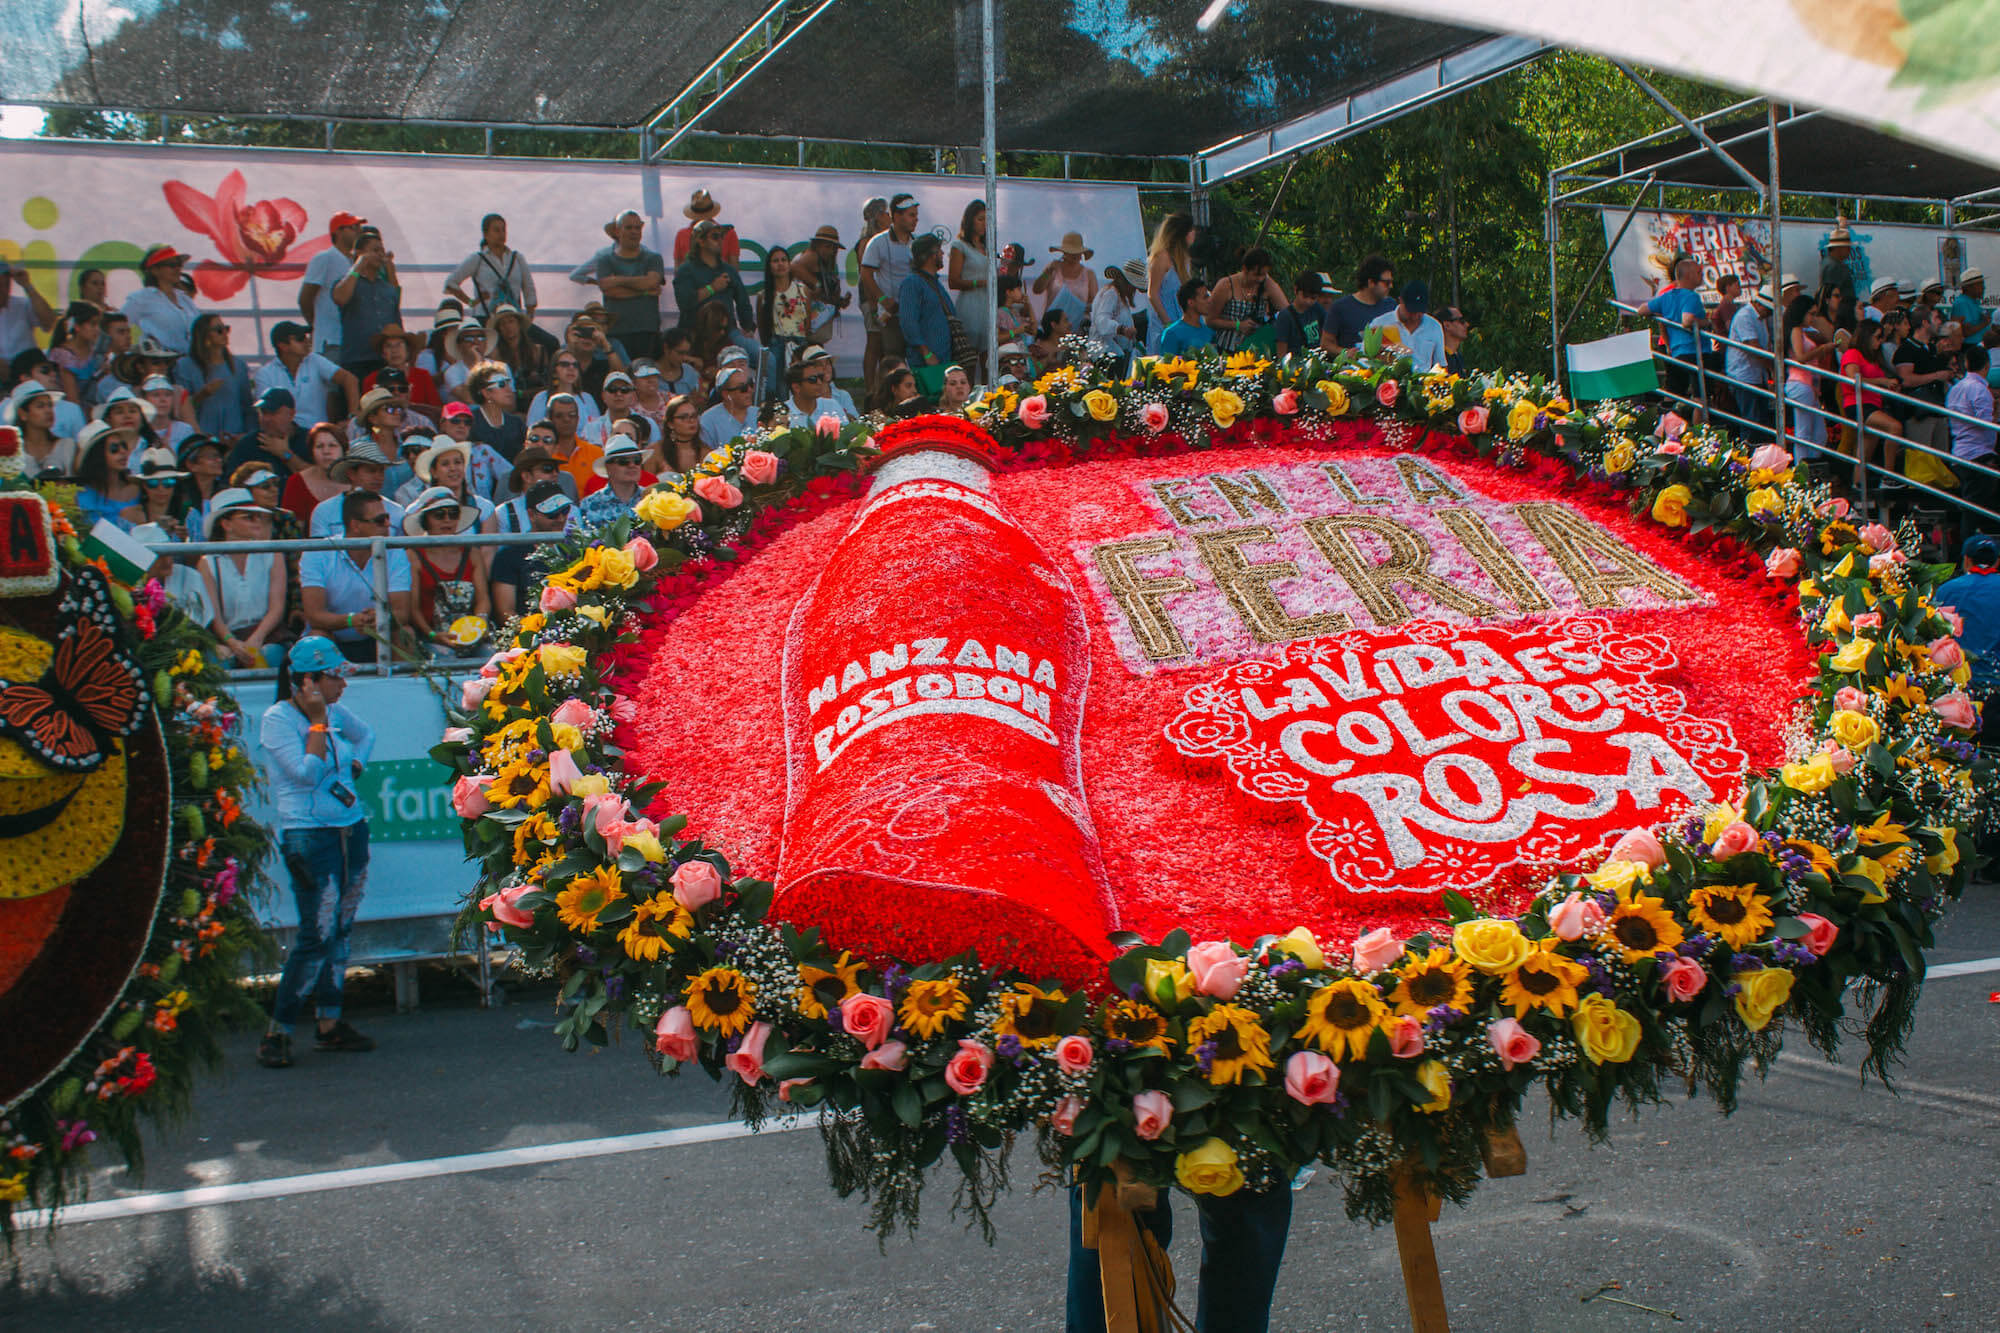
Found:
16,1117 -> 818,1231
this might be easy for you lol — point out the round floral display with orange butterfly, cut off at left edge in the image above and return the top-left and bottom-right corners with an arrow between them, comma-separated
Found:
0,472 -> 268,1239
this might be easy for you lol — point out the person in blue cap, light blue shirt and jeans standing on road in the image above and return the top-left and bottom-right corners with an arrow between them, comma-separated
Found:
256,634 -> 374,1069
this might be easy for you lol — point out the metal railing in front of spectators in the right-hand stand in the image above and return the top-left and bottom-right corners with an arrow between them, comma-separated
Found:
1606,300 -> 2000,524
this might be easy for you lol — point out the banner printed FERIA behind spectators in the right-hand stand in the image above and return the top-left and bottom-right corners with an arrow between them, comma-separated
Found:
1600,208 -> 2000,304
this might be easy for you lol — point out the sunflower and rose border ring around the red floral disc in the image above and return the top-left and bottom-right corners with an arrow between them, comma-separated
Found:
434,334 -> 1978,1231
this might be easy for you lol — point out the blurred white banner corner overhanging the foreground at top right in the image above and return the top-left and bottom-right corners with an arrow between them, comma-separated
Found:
1296,0 -> 2000,164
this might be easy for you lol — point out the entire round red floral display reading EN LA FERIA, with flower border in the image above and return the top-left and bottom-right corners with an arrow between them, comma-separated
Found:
436,324 -> 1978,1229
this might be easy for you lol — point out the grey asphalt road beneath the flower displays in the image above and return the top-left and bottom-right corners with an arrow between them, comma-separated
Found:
0,887 -> 2000,1333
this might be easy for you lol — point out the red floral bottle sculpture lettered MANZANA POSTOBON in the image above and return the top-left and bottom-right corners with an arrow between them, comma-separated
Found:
778,416 -> 1116,979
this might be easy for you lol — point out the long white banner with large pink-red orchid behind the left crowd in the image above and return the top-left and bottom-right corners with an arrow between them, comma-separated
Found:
0,140 -> 1146,372
